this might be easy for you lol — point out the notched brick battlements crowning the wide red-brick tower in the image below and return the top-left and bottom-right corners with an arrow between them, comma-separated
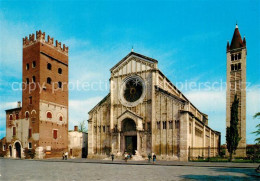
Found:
23,30 -> 69,54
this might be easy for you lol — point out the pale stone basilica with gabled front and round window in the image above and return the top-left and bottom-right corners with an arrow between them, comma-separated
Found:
88,51 -> 220,161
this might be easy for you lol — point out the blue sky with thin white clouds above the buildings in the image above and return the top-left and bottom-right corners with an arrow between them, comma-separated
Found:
0,0 -> 260,143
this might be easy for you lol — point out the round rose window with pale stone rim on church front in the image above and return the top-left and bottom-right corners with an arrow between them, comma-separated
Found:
120,76 -> 145,107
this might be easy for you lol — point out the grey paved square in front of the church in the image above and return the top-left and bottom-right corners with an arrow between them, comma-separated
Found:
0,159 -> 259,181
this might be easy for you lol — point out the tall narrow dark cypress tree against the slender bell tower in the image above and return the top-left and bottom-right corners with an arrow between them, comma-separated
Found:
226,95 -> 241,161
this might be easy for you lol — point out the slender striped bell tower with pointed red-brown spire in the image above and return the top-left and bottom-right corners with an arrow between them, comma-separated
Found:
226,25 -> 247,156
